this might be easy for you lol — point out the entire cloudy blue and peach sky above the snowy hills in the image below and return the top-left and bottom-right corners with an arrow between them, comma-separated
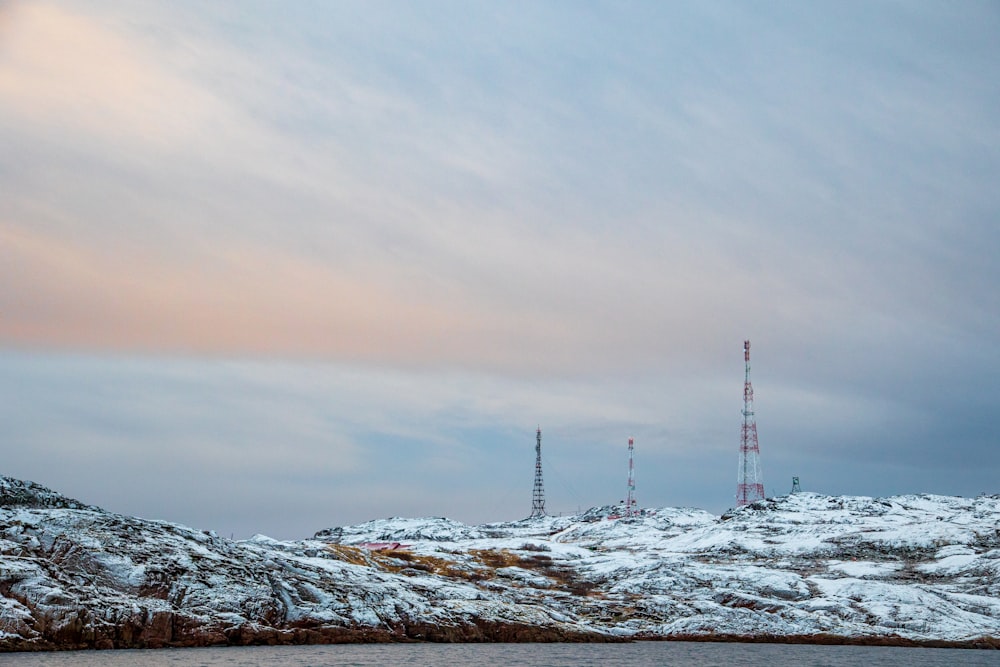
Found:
0,0 -> 1000,539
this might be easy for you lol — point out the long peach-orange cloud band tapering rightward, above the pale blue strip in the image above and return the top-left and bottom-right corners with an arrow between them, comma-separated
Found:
0,225 -> 576,370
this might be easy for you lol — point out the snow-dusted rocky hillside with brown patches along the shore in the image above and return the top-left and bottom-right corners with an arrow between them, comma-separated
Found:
0,477 -> 1000,650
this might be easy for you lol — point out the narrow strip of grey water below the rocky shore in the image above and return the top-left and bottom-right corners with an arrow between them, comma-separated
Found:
0,642 -> 1000,667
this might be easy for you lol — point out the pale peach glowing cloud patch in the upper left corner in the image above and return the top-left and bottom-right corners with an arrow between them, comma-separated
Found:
0,3 -> 231,150
